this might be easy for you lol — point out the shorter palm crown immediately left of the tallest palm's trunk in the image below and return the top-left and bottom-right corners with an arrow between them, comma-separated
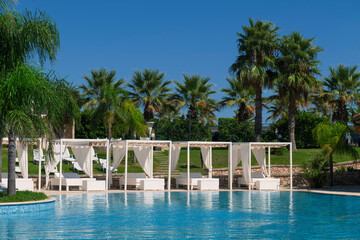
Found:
220,77 -> 255,122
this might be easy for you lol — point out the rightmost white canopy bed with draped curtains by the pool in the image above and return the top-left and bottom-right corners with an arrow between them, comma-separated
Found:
228,142 -> 293,190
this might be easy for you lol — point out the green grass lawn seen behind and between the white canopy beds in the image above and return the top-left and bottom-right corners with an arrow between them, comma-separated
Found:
2,147 -> 360,174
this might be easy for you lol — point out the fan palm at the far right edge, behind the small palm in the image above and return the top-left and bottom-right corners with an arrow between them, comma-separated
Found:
323,64 -> 360,124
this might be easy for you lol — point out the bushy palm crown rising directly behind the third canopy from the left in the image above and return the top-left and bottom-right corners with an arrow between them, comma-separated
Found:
174,74 -> 217,120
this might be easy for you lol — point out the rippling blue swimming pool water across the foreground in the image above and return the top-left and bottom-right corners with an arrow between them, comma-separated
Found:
0,192 -> 360,239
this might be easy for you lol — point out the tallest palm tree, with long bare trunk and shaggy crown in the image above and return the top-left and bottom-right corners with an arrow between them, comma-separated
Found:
230,18 -> 279,142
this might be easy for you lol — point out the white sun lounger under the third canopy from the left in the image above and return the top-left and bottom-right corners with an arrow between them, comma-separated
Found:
175,173 -> 219,190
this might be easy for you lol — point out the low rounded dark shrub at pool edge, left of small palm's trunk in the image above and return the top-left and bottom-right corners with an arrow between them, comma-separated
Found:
302,155 -> 329,188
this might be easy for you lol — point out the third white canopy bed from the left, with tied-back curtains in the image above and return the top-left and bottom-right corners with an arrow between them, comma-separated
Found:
169,141 -> 232,190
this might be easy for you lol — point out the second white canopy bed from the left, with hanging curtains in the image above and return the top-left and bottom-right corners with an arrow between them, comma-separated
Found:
107,140 -> 172,191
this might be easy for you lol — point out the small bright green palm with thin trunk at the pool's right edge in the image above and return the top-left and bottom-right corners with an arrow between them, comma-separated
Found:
313,123 -> 359,186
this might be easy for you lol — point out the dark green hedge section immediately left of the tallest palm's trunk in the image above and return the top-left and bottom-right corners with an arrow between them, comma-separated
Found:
218,118 -> 254,142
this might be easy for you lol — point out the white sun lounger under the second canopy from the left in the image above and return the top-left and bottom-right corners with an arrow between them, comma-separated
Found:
119,173 -> 165,190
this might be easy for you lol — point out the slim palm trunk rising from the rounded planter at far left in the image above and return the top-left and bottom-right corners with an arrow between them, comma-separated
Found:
8,131 -> 16,196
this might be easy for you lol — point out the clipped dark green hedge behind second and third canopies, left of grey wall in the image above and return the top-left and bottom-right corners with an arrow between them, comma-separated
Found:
154,118 -> 211,141
